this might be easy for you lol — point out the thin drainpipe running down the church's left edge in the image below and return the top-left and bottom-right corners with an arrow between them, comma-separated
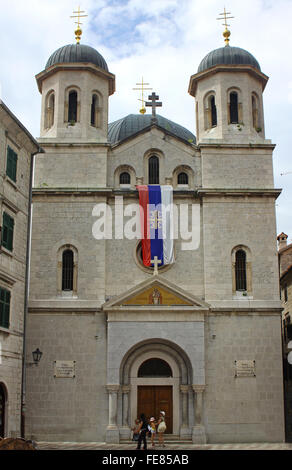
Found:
20,148 -> 45,438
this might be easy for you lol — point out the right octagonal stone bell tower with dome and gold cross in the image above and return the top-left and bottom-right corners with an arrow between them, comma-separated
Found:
189,9 -> 268,144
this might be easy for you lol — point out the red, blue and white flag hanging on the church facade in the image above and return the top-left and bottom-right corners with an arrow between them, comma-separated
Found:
137,185 -> 174,266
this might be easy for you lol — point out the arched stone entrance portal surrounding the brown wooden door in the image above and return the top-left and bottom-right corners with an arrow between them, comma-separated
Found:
120,339 -> 192,435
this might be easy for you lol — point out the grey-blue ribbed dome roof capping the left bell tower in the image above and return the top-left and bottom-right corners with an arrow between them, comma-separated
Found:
45,44 -> 108,72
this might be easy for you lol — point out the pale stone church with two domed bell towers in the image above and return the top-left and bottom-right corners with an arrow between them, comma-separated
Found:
26,30 -> 284,443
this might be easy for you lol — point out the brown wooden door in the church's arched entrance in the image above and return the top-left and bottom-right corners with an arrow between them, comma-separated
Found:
137,385 -> 173,434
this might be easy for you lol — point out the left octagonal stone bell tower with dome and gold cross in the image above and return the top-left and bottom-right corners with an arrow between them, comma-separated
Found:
36,10 -> 115,143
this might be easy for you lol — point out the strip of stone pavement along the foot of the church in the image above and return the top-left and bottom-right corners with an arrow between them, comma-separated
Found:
36,441 -> 292,451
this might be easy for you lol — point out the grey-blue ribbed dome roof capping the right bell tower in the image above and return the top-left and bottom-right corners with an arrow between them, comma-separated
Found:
198,45 -> 261,73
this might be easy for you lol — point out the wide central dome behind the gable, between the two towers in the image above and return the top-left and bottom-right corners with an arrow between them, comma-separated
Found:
108,114 -> 196,144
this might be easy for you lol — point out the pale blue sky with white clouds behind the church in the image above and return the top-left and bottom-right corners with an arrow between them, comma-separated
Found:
0,0 -> 292,243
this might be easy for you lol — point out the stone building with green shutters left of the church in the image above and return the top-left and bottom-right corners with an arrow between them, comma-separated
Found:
0,100 -> 40,437
